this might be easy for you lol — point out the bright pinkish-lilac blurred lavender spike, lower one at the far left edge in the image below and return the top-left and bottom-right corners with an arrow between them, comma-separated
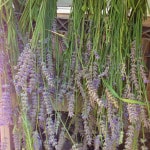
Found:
0,84 -> 12,126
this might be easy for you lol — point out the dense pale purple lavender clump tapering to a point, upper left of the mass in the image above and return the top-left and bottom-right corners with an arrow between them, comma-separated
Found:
14,43 -> 36,94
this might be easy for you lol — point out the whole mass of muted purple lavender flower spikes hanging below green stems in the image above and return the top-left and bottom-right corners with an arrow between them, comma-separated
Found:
8,35 -> 149,150
